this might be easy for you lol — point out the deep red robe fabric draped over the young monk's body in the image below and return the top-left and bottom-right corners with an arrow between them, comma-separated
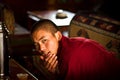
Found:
57,36 -> 120,80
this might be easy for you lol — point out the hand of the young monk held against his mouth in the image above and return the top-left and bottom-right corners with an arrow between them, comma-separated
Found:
40,54 -> 58,73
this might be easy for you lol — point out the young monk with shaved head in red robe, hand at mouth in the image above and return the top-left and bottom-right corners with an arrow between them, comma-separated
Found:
31,19 -> 120,80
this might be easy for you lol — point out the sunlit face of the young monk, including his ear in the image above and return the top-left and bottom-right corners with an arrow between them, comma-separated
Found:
32,30 -> 61,56
